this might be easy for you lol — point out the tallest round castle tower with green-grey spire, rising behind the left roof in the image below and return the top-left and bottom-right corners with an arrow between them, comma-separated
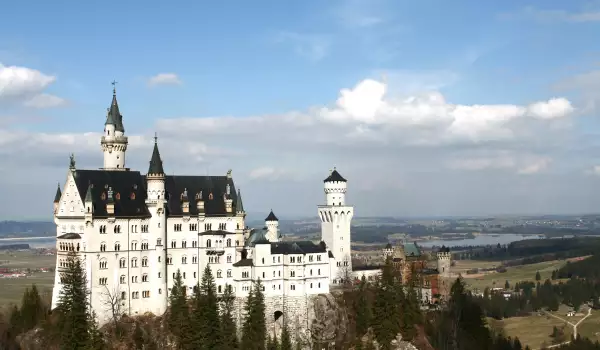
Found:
100,82 -> 128,170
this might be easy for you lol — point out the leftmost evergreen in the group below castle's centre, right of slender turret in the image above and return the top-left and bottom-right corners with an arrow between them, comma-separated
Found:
167,270 -> 190,349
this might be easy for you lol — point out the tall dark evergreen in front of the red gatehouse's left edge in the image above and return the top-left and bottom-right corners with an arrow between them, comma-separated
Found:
372,257 -> 401,350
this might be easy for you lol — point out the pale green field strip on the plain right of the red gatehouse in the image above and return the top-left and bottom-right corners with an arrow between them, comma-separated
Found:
457,260 -> 566,290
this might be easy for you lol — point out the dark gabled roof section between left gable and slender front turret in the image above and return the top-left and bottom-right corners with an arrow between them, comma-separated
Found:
73,170 -> 150,217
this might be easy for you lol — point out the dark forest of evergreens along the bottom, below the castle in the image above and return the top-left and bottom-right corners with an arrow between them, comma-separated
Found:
0,255 -> 600,350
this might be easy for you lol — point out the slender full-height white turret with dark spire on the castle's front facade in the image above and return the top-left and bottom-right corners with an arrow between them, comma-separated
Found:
141,136 -> 168,315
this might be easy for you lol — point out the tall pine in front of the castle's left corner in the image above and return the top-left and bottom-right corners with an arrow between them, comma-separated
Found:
57,252 -> 91,349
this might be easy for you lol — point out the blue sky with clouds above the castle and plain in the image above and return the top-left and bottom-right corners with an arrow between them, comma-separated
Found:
0,0 -> 600,216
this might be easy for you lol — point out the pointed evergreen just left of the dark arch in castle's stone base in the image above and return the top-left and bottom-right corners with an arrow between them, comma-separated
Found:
241,279 -> 267,350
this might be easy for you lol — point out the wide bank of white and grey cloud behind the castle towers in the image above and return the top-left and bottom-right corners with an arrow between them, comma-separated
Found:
0,79 -> 590,219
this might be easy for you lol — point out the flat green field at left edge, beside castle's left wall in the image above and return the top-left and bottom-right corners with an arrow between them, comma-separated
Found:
0,251 -> 56,308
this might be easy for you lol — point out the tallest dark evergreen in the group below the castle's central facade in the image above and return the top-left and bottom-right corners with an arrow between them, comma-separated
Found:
191,265 -> 221,350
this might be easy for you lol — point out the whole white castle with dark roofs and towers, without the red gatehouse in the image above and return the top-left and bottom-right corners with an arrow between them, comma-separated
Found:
52,90 -> 354,324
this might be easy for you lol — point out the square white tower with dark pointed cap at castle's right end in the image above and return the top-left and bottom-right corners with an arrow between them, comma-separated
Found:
318,168 -> 354,283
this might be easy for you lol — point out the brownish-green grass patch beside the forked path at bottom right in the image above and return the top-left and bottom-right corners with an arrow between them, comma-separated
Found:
488,315 -> 572,349
